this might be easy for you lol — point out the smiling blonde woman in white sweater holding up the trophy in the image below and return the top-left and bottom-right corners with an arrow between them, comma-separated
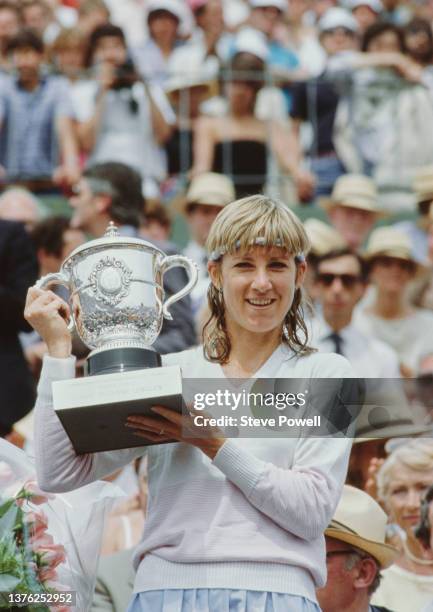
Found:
25,195 -> 352,612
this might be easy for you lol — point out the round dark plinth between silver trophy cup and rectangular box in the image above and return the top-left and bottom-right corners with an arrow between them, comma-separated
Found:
86,347 -> 161,376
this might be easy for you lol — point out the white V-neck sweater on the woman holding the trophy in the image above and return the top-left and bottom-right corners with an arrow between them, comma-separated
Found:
35,346 -> 353,601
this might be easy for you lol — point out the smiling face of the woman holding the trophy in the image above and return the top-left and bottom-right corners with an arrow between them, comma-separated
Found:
209,246 -> 306,333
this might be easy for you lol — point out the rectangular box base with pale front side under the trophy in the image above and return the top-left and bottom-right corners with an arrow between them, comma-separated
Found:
53,366 -> 183,455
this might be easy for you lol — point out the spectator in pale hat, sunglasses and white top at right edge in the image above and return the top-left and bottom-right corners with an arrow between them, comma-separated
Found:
355,227 -> 433,376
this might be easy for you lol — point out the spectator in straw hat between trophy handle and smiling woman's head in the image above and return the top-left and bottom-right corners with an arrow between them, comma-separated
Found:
181,172 -> 235,312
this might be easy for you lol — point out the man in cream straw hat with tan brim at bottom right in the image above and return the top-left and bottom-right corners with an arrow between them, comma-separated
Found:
317,485 -> 397,612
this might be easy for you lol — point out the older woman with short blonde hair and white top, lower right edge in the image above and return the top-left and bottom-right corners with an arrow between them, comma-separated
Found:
373,439 -> 433,612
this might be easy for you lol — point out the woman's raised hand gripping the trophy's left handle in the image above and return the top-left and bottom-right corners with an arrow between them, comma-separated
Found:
24,287 -> 72,358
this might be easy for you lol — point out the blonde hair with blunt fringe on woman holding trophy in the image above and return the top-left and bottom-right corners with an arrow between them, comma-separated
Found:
203,195 -> 314,364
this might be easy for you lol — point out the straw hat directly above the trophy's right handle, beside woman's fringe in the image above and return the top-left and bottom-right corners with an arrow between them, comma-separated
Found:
173,172 -> 236,213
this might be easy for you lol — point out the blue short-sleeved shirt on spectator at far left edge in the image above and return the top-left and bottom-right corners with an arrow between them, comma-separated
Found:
0,76 -> 73,180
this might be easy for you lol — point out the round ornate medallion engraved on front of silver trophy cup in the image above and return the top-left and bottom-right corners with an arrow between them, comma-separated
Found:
89,256 -> 132,306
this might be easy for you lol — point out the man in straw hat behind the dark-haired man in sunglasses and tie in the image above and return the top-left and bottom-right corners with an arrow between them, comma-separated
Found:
321,174 -> 382,251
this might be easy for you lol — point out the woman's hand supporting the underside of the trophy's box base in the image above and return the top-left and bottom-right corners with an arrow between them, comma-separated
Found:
126,406 -> 226,459
